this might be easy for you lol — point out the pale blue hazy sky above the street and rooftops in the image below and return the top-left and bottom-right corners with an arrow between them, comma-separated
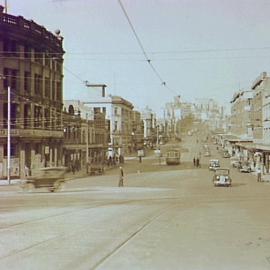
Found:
6,0 -> 270,114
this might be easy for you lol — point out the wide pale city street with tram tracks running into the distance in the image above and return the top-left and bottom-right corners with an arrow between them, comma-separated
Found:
0,137 -> 270,270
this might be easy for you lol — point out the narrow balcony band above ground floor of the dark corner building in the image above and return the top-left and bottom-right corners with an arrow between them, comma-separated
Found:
0,129 -> 64,138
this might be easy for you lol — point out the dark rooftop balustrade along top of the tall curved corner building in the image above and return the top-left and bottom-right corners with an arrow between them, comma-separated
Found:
0,13 -> 62,48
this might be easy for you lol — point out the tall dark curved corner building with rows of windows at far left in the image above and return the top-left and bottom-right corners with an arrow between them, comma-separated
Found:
0,9 -> 64,178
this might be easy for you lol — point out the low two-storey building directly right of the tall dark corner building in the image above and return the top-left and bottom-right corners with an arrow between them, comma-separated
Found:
63,100 -> 108,167
